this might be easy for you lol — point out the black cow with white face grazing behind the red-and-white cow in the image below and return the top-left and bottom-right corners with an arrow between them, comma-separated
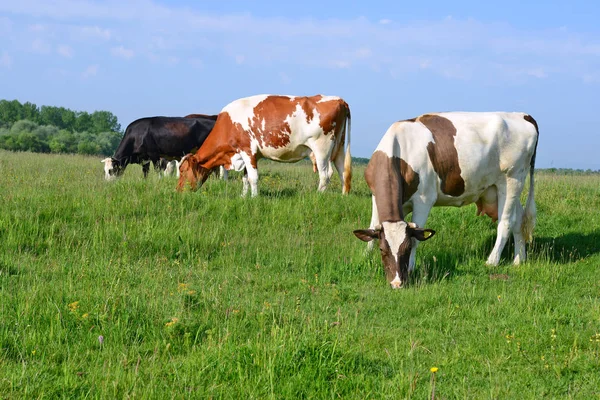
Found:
102,114 -> 217,180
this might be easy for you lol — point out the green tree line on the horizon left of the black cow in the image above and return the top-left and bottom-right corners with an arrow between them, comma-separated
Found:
0,100 -> 123,156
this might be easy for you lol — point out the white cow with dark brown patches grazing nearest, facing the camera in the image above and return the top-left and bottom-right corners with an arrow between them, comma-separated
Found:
354,112 -> 538,288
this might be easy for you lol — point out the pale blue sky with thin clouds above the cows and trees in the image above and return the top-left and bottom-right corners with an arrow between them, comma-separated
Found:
0,0 -> 600,170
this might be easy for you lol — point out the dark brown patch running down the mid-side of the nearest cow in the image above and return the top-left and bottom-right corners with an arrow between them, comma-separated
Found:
417,114 -> 465,197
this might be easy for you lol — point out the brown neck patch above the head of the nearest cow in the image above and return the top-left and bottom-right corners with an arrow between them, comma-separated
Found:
365,150 -> 404,222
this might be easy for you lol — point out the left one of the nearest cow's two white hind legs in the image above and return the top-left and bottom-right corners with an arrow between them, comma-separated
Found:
486,177 -> 523,265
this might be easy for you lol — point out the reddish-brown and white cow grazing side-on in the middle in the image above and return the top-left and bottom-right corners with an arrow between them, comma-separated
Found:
177,95 -> 352,196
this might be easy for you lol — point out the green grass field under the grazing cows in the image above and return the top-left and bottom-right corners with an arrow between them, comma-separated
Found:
0,152 -> 600,399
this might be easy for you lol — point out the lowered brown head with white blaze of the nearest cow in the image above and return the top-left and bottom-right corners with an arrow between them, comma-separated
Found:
354,221 -> 435,289
